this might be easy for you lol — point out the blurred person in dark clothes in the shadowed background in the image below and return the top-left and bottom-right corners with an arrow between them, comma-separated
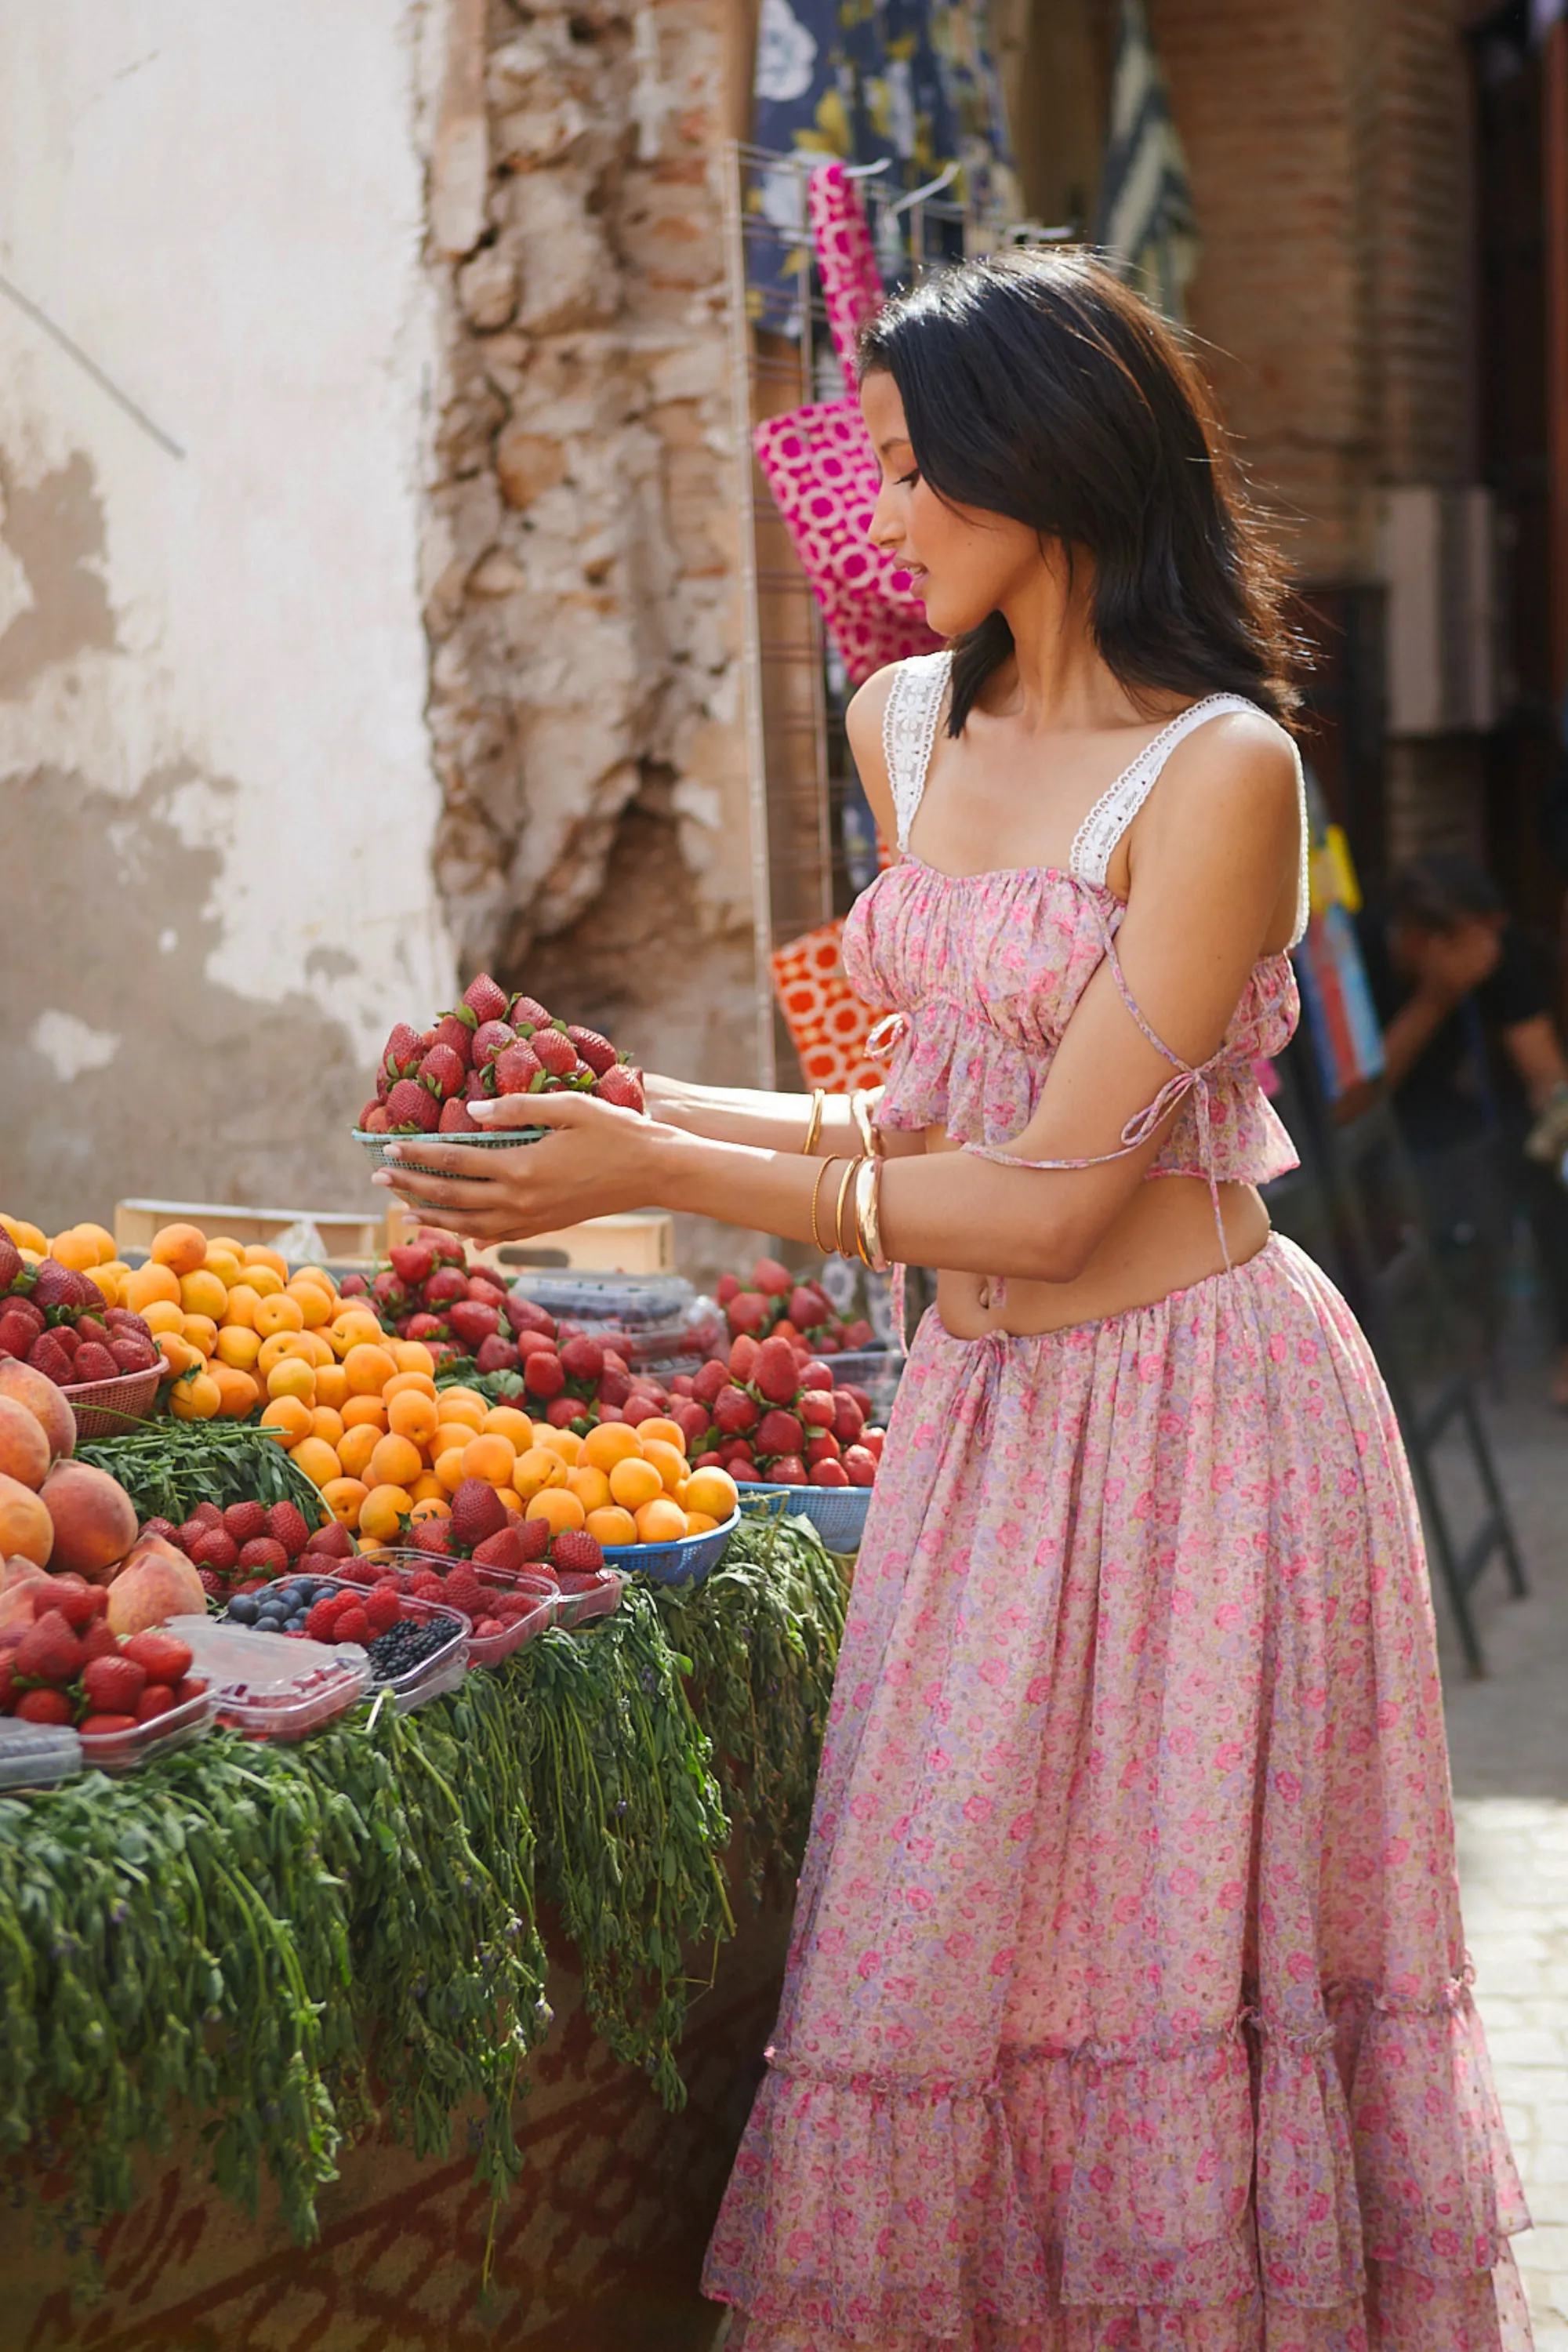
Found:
1361,854 -> 1568,1409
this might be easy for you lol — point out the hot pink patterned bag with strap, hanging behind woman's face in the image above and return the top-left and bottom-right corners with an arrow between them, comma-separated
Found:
753,162 -> 940,684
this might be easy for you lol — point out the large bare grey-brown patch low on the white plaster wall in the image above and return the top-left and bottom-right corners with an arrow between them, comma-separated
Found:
0,767 -> 374,1232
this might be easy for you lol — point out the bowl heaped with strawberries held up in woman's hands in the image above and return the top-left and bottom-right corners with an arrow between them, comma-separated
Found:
355,971 -> 644,1176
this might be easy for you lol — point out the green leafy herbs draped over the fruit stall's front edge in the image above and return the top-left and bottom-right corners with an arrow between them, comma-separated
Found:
0,1515 -> 844,2241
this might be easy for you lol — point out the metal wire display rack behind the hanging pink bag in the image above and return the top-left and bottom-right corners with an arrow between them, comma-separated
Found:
724,143 -> 1058,1087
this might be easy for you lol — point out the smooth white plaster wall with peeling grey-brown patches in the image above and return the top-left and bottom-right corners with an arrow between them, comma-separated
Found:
0,0 -> 454,1223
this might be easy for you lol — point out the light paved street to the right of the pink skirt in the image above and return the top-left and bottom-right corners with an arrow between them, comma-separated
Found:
1436,1362 -> 1568,2352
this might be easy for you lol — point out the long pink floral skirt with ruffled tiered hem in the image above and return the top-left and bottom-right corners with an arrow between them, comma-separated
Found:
706,1237 -> 1530,2352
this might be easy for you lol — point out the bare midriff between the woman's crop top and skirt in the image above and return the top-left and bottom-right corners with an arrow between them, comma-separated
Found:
926,1127 -> 1269,1338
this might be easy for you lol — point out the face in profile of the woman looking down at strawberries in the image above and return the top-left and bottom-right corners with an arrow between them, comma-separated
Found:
860,369 -> 1046,637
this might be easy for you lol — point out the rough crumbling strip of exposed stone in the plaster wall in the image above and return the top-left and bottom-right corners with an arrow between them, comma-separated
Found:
426,0 -> 755,1120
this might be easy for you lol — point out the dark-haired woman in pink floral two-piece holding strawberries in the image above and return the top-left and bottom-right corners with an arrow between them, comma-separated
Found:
380,254 -> 1528,2352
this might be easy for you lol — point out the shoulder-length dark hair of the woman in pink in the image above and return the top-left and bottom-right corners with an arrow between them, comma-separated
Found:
860,249 -> 1300,734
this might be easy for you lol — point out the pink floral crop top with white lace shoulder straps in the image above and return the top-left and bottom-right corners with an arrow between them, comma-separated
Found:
844,654 -> 1307,1211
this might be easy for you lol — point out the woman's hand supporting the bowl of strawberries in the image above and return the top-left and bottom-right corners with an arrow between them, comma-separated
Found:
372,1094 -> 675,1242
